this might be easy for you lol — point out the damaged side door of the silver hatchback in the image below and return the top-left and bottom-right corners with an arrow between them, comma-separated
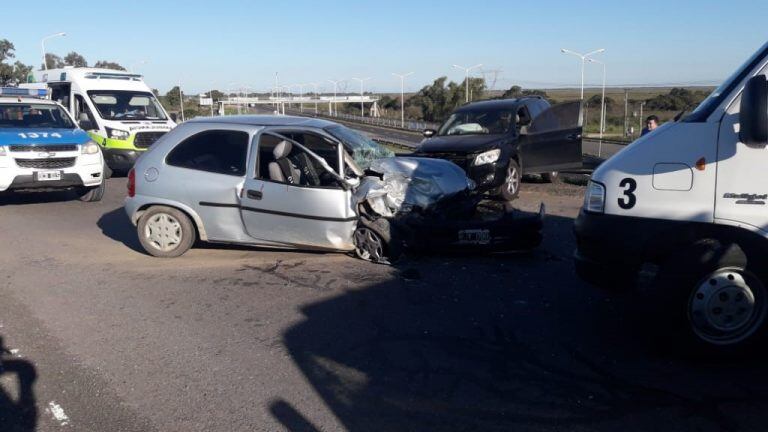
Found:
241,128 -> 357,250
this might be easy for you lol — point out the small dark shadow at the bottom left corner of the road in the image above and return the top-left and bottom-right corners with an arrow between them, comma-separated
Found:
0,337 -> 38,432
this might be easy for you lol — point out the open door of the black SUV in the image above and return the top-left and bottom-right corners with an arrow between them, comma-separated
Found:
520,102 -> 582,174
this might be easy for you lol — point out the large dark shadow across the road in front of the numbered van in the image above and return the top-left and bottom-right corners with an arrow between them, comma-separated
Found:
280,216 -> 768,431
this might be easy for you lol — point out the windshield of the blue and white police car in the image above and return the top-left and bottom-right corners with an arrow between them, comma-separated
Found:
0,103 -> 75,129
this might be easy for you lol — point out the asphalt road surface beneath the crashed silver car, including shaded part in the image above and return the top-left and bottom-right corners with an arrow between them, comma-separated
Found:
0,178 -> 768,431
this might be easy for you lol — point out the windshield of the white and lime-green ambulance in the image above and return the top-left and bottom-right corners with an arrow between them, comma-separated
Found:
88,90 -> 166,120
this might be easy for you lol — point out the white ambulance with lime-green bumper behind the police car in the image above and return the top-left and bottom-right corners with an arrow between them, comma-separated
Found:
32,67 -> 176,171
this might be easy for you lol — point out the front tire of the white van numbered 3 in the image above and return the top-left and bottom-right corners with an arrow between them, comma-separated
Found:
645,240 -> 768,357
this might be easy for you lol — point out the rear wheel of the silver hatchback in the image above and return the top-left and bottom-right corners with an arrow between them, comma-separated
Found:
136,206 -> 197,258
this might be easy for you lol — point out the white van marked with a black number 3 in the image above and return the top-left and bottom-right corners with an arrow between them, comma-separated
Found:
575,39 -> 768,352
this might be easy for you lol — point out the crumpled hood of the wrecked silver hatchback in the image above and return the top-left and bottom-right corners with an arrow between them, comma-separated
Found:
355,157 -> 475,216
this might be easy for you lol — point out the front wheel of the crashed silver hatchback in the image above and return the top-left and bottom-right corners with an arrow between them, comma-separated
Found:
352,218 -> 402,264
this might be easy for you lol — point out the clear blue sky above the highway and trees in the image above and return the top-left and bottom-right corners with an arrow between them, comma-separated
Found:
0,0 -> 768,94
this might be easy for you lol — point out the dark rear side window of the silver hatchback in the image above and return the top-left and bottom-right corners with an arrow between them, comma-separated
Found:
165,130 -> 248,176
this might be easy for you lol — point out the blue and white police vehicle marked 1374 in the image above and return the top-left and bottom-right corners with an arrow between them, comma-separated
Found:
0,87 -> 106,201
